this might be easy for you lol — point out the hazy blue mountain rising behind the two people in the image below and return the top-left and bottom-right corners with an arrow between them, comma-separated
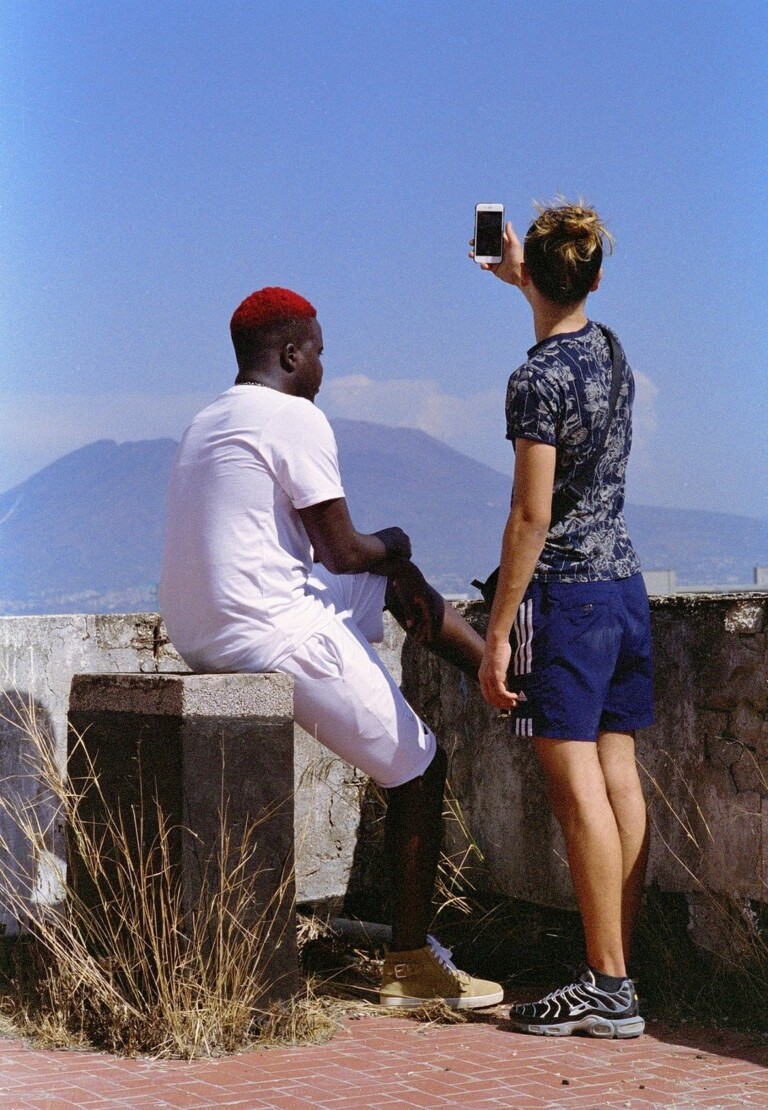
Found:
0,420 -> 768,614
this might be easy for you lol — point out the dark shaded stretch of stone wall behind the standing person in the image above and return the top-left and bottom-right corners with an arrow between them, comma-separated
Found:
403,594 -> 768,948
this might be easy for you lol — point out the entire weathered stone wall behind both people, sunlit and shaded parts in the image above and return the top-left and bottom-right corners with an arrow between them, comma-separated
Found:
0,594 -> 768,945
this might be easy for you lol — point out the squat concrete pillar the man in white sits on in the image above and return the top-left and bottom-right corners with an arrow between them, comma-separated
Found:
69,674 -> 299,1000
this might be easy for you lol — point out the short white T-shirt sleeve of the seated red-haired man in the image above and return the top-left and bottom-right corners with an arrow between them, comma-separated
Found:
260,397 -> 344,508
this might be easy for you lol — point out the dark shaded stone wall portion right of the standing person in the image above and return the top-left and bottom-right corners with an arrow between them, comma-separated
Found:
638,594 -> 768,952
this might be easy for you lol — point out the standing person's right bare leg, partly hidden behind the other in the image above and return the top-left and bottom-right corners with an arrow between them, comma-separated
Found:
597,733 -> 648,960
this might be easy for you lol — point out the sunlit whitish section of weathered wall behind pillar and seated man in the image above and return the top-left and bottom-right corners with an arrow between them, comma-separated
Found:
0,613 -> 395,928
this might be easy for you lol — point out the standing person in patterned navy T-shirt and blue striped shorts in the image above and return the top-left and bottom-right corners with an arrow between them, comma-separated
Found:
479,202 -> 654,1037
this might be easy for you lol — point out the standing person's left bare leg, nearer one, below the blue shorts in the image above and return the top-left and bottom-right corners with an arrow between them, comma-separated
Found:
534,738 -> 627,976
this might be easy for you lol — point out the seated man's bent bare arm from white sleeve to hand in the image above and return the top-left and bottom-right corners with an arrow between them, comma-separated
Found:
299,497 -> 411,575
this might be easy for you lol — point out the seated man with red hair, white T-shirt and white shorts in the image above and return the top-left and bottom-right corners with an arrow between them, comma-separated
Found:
160,289 -> 502,1009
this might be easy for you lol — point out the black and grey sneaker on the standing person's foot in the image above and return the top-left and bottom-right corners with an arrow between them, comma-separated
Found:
509,968 -> 645,1037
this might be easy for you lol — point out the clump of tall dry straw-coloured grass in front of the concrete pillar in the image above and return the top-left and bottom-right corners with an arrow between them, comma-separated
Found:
0,683 -> 333,1058
